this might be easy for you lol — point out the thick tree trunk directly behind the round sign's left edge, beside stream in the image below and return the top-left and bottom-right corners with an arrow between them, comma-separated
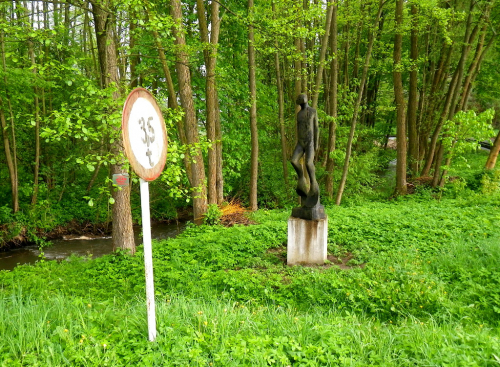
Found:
91,1 -> 135,254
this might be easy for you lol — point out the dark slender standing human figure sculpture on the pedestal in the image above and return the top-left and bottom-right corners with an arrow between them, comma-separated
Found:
291,94 -> 326,219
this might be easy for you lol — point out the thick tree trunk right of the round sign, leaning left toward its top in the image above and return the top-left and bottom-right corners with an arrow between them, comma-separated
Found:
170,0 -> 207,224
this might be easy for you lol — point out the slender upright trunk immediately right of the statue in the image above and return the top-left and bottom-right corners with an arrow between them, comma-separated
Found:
326,3 -> 339,199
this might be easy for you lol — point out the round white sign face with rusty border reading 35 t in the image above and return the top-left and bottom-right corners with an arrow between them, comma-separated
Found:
122,88 -> 167,181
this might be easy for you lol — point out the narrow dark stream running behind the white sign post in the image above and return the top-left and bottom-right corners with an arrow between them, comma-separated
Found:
0,223 -> 184,270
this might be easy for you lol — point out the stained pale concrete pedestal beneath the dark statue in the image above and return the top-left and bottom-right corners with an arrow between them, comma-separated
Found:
286,217 -> 328,265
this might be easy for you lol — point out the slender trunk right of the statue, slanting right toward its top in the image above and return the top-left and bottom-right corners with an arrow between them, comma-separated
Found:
335,0 -> 384,205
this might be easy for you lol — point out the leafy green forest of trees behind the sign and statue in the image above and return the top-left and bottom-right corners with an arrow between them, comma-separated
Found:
0,0 -> 500,251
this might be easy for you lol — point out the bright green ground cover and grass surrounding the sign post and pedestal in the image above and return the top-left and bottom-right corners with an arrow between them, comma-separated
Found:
0,192 -> 500,366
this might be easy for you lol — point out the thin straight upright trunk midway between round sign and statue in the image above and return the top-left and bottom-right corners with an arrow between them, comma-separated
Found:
248,0 -> 259,211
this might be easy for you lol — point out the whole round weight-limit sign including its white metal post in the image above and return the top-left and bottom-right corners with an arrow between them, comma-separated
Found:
122,88 -> 167,341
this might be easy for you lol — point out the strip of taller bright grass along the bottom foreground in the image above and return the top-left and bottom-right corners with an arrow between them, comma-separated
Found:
0,290 -> 500,367
